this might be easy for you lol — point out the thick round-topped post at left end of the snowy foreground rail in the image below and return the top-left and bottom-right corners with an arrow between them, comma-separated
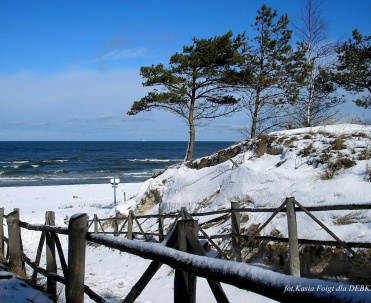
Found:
66,214 -> 88,303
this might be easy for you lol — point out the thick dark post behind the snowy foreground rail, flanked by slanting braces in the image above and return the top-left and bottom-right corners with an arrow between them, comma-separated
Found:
174,219 -> 198,303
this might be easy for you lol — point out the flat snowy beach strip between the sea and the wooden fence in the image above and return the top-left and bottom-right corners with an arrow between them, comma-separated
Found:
0,183 -> 142,225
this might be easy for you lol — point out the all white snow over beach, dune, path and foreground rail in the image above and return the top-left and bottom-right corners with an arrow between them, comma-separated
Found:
0,124 -> 371,303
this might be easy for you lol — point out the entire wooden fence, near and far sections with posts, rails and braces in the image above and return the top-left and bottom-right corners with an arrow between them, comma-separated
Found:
0,197 -> 371,303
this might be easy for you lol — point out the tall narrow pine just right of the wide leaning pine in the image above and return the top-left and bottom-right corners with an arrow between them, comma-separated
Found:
234,5 -> 306,138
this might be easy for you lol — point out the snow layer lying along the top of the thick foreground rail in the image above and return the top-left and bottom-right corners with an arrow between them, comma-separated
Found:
91,235 -> 371,302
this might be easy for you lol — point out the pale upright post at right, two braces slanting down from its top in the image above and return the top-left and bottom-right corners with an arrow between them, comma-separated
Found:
286,197 -> 300,277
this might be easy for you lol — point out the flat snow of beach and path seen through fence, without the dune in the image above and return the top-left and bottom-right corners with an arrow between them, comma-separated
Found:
0,183 -> 273,303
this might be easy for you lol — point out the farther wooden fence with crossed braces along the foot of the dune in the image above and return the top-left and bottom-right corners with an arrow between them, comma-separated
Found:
83,197 -> 371,261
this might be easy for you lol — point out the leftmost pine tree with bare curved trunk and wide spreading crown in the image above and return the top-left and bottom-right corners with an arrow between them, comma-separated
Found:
128,31 -> 242,161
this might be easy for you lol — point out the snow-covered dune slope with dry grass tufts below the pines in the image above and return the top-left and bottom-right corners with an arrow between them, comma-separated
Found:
125,125 -> 371,246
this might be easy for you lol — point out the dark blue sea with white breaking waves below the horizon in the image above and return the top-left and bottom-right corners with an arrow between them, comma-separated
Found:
0,141 -> 233,187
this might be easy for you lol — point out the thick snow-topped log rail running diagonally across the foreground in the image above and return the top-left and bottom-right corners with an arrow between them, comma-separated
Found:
87,234 -> 371,303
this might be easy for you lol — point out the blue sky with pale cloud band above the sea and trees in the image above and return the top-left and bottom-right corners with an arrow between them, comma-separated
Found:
0,0 -> 371,141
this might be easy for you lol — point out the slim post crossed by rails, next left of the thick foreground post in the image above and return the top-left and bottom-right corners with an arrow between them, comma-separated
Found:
45,211 -> 58,302
